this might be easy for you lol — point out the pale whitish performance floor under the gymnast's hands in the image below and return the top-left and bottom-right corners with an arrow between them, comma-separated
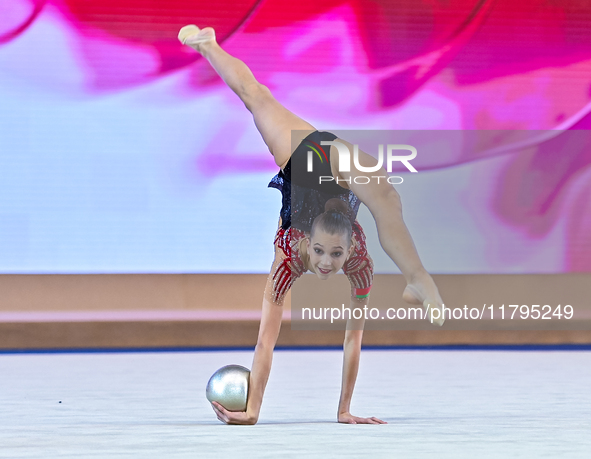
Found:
0,350 -> 591,458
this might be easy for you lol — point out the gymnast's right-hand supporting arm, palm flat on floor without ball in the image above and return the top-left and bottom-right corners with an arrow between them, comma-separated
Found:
337,288 -> 387,424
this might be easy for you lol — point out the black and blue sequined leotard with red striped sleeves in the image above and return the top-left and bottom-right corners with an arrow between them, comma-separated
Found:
269,131 -> 373,302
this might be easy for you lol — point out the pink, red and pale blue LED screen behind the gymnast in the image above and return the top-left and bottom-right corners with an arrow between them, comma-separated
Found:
0,0 -> 591,273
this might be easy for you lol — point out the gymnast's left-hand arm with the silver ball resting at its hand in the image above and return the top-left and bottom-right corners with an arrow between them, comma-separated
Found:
212,252 -> 287,424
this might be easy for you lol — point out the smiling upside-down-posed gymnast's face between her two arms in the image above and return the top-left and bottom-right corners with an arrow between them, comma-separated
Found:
307,228 -> 352,280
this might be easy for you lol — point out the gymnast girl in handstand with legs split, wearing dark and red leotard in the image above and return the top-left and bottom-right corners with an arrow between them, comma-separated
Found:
178,25 -> 443,424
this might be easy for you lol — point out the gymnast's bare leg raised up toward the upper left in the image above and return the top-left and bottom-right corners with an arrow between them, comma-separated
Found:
179,25 -> 315,168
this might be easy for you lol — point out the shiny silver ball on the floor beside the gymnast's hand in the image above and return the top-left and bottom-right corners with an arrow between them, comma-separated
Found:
205,365 -> 250,411
